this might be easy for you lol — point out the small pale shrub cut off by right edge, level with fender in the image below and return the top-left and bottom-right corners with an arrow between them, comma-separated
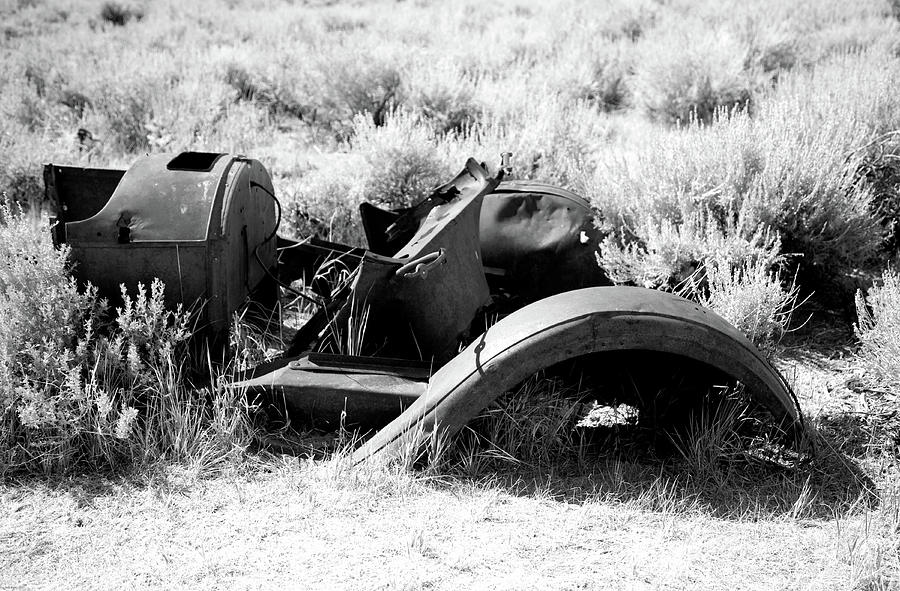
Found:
855,269 -> 900,393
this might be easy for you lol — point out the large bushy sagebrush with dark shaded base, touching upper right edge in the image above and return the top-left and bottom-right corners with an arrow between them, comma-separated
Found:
744,55 -> 900,274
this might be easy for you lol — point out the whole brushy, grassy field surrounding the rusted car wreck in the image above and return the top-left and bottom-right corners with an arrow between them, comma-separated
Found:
0,0 -> 900,590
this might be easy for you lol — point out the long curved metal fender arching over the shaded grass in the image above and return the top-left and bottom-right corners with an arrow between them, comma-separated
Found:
353,287 -> 803,464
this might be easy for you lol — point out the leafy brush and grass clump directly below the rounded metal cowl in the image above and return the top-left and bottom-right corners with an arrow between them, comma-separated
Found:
104,279 -> 252,469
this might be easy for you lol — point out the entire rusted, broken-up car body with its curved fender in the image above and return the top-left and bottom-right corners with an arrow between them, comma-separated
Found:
45,153 -> 803,462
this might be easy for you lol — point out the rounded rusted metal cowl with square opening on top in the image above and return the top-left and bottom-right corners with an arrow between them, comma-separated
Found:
50,152 -> 276,333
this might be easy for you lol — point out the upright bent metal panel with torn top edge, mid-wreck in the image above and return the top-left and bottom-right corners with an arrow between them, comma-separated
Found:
304,159 -> 496,365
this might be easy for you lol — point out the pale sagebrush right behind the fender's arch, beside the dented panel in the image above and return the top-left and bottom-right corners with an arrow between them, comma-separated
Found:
579,112 -> 778,288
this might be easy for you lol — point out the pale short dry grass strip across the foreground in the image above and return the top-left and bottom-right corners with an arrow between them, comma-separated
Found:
0,434 -> 898,589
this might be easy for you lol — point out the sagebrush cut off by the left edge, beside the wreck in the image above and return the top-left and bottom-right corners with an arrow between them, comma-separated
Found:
0,202 -> 103,470
